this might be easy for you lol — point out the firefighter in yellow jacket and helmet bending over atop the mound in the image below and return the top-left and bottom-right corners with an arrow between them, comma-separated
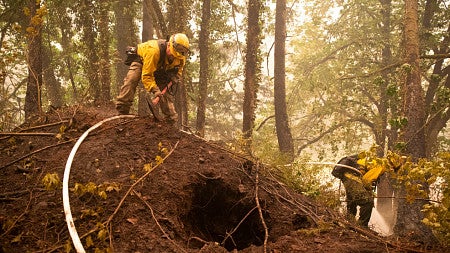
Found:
115,33 -> 189,123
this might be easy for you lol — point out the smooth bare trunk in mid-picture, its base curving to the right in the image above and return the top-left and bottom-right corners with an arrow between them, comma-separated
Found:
274,0 -> 294,163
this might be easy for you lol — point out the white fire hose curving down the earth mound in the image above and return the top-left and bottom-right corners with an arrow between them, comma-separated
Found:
63,115 -> 136,253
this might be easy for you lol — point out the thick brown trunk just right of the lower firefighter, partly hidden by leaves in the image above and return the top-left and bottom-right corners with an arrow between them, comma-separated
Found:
394,0 -> 433,241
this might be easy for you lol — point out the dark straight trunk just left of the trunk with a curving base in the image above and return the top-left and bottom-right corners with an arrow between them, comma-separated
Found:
242,0 -> 262,153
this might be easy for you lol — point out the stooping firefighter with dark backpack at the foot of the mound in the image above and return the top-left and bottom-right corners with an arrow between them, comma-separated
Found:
331,155 -> 385,227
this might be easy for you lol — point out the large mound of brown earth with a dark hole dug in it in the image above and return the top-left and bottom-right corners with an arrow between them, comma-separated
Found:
0,106 -> 442,253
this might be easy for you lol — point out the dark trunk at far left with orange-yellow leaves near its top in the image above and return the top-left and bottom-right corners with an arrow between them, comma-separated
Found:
24,0 -> 42,119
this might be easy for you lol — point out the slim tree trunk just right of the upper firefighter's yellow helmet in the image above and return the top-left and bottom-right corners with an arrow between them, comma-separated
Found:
197,0 -> 211,137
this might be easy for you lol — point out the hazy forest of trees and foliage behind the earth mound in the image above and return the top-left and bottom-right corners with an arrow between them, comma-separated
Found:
0,0 -> 450,246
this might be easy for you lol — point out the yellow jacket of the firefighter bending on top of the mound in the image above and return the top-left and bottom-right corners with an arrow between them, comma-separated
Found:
137,40 -> 186,91
